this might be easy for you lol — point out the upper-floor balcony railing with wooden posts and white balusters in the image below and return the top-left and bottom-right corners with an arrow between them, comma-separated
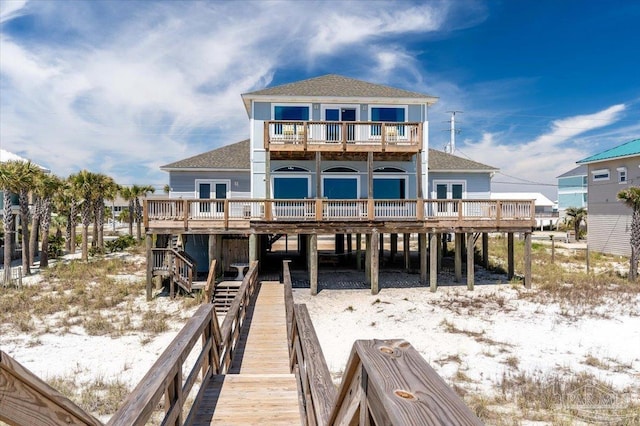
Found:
264,121 -> 422,152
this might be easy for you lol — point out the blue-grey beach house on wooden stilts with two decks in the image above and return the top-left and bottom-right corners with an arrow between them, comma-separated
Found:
144,75 -> 535,297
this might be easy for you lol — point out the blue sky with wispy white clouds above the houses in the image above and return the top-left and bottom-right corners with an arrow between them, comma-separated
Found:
0,0 -> 640,200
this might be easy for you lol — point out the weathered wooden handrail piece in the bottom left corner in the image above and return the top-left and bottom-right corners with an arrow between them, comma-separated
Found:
0,351 -> 102,426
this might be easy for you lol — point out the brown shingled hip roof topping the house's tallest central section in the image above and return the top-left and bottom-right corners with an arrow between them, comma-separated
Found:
242,74 -> 438,115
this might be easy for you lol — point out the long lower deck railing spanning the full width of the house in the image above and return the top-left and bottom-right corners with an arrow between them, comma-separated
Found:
144,199 -> 535,229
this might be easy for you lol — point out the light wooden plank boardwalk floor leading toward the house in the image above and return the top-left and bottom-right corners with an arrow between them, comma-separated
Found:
193,281 -> 301,425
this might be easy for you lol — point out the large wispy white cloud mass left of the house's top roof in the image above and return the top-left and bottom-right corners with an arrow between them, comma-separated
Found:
0,1 -> 464,183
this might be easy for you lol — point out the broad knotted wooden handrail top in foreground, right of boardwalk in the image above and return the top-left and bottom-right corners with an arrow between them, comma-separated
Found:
329,340 -> 483,425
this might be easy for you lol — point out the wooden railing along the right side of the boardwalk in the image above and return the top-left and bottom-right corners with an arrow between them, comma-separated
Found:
283,261 -> 482,426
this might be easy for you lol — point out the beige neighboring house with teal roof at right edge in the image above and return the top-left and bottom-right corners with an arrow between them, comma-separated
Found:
578,139 -> 640,256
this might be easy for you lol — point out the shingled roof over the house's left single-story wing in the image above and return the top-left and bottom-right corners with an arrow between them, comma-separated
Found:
160,139 -> 250,171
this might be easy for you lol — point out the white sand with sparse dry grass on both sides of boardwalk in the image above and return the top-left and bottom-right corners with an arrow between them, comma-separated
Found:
0,251 -> 640,421
